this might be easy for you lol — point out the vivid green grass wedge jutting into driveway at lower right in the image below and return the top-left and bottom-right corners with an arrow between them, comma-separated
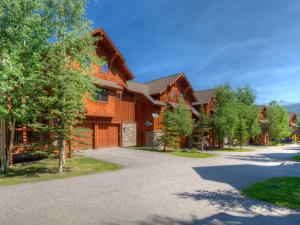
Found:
242,177 -> 300,209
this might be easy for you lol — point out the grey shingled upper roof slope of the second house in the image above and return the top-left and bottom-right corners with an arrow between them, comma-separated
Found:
145,74 -> 182,95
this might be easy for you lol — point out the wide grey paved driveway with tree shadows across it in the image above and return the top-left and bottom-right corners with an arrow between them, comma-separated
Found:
0,145 -> 300,225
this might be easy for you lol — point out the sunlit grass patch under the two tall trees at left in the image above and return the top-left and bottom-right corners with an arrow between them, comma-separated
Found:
0,156 -> 121,185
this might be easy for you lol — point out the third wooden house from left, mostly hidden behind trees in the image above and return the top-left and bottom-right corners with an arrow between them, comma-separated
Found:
193,89 -> 216,148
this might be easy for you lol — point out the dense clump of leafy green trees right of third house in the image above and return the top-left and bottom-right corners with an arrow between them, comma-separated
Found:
212,84 -> 261,146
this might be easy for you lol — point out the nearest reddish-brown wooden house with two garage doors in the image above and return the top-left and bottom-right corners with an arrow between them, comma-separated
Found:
76,29 -> 136,149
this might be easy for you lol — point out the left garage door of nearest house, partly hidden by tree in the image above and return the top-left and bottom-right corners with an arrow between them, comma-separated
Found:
75,123 -> 94,150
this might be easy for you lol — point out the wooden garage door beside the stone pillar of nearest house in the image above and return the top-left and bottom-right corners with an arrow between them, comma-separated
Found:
97,124 -> 119,148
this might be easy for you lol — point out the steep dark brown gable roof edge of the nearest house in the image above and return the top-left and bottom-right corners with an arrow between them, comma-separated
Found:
92,28 -> 134,80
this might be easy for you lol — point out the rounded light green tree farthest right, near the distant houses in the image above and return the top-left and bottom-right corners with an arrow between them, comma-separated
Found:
267,101 -> 291,142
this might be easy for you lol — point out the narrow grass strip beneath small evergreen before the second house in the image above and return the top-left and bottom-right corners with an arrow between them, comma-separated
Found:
130,147 -> 216,158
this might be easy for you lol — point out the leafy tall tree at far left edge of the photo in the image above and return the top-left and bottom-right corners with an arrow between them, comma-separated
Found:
0,0 -> 49,174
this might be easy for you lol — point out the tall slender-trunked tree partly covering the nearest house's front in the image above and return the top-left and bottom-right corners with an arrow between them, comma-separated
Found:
31,0 -> 102,173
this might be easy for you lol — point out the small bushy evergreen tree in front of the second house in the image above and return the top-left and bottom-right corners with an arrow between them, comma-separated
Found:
162,99 -> 194,151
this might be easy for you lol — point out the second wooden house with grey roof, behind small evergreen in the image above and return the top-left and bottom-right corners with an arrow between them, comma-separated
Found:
127,73 -> 198,146
